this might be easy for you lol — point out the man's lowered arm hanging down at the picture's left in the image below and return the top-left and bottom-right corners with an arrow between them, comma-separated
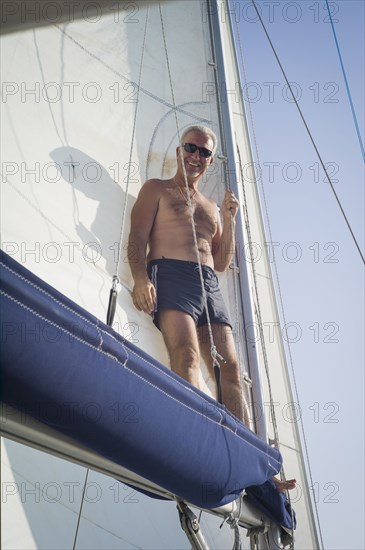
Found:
128,180 -> 159,313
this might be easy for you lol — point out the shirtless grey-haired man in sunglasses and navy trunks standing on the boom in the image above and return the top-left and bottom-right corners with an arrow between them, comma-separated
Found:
128,126 -> 295,491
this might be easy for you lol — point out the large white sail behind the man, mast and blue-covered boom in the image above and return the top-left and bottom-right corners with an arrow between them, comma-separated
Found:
1,0 -> 316,549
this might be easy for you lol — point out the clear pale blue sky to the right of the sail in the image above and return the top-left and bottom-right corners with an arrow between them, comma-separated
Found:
232,0 -> 365,550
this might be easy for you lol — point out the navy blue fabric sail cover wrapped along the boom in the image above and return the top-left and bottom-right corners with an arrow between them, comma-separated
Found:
0,252 -> 292,523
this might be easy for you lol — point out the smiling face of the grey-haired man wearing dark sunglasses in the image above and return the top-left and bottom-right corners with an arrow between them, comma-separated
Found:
176,132 -> 213,178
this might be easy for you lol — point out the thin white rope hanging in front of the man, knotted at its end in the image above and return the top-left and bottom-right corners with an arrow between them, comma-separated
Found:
159,3 -> 224,382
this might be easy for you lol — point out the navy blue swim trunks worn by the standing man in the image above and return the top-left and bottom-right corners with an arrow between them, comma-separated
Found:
147,258 -> 232,329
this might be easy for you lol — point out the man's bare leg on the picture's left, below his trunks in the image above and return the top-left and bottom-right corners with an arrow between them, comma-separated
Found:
159,309 -> 200,388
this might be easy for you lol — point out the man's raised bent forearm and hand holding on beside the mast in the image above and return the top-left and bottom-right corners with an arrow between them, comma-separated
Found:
212,191 -> 239,271
